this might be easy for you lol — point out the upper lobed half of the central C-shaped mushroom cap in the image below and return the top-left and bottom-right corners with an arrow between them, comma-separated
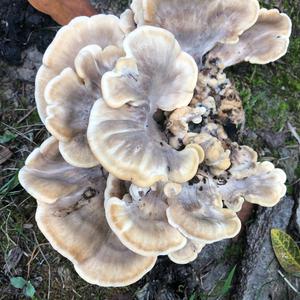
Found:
102,26 -> 198,113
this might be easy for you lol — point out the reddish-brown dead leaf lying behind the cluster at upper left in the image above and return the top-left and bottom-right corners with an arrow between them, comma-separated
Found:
28,0 -> 97,25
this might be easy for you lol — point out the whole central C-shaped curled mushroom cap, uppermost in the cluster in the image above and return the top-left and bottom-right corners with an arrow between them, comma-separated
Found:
88,26 -> 200,187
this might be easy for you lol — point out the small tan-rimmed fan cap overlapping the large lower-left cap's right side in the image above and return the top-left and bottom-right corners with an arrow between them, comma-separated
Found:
105,175 -> 186,256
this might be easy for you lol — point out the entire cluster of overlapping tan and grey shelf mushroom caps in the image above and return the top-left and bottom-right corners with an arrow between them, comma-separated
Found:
19,0 -> 291,286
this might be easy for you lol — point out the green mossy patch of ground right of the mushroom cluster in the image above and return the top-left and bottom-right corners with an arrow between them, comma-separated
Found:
229,0 -> 300,132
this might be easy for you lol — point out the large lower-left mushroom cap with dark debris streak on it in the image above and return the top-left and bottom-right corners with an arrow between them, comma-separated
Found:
19,138 -> 156,286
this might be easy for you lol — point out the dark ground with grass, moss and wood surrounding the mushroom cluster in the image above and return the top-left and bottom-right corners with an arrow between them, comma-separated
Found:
0,0 -> 300,300
